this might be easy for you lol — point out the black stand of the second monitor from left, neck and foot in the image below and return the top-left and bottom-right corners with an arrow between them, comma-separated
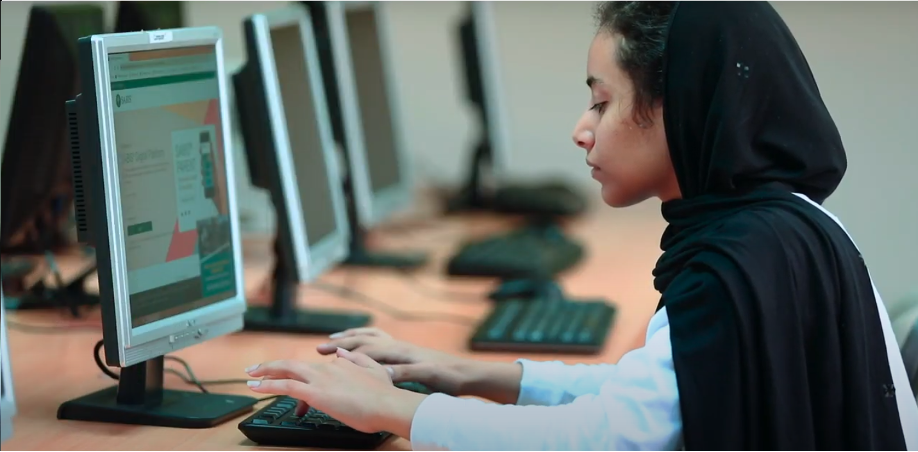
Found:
245,234 -> 370,335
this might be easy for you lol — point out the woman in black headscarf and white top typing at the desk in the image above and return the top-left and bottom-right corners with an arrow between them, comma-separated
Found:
249,2 -> 918,450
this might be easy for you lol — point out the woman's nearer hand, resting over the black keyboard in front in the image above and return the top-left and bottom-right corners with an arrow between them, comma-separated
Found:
246,349 -> 425,438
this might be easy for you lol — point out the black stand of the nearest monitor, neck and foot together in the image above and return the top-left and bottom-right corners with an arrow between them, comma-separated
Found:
57,356 -> 258,429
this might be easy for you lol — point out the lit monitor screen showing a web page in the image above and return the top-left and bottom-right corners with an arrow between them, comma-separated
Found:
108,45 -> 238,328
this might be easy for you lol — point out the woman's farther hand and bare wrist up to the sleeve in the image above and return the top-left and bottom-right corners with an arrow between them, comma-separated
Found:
317,328 -> 522,404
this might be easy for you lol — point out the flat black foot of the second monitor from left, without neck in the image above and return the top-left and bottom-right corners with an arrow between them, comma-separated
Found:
245,306 -> 370,335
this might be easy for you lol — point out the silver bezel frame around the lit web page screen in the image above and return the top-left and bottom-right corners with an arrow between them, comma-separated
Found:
90,27 -> 246,367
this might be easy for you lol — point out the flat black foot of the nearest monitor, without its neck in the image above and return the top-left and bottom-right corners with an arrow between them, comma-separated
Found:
57,387 -> 258,429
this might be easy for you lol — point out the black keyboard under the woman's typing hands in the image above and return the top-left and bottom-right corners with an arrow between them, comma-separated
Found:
239,383 -> 430,450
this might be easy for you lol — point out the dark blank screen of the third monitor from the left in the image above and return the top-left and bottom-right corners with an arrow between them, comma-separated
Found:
347,8 -> 401,193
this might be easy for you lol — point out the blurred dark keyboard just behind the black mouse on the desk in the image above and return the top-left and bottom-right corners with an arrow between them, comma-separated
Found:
446,225 -> 584,279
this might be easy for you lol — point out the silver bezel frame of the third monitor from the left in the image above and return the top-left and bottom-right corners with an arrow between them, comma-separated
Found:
336,1 -> 415,228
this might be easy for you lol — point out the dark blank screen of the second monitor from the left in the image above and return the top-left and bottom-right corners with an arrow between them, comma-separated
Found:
271,24 -> 336,247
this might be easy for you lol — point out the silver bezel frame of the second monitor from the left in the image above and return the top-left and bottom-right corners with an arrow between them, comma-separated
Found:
251,5 -> 350,282
